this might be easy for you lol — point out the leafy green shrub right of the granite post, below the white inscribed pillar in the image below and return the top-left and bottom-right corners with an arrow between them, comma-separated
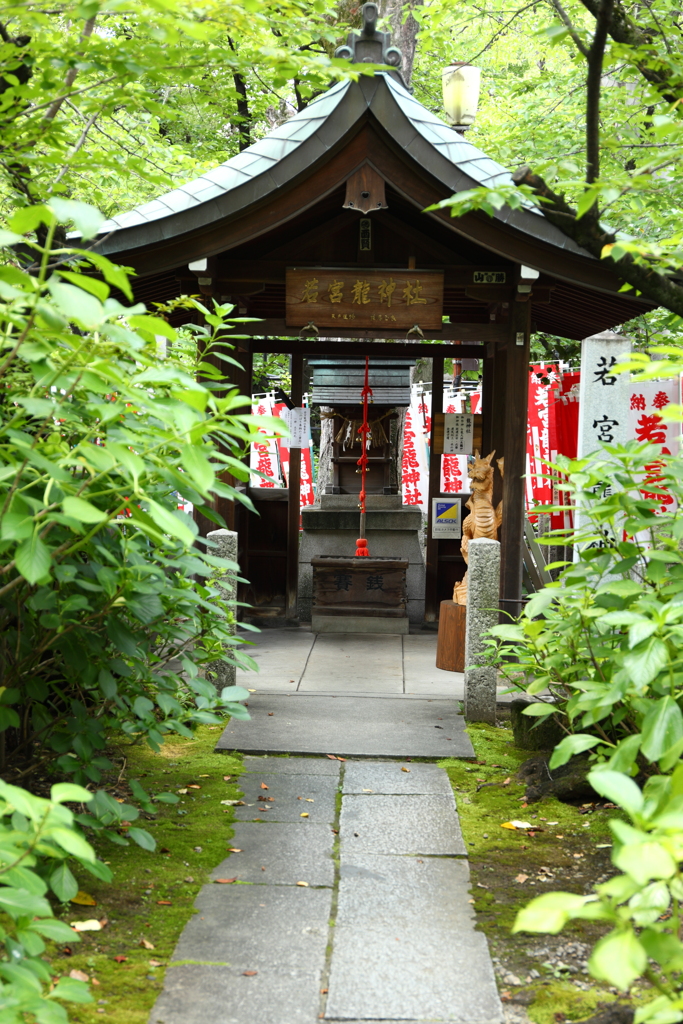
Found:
485,442 -> 683,774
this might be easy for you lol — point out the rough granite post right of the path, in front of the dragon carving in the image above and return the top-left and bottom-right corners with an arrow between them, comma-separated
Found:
465,537 -> 501,723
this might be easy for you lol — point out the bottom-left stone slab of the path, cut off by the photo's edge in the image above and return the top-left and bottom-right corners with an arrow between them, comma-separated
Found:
150,966 -> 321,1024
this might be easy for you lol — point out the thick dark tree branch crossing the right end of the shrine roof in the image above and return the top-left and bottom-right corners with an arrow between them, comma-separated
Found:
512,166 -> 683,316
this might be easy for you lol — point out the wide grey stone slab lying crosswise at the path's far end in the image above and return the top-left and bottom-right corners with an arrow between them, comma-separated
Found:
216,692 -> 474,759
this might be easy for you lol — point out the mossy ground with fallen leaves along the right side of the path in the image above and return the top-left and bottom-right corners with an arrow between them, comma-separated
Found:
439,725 -> 634,1024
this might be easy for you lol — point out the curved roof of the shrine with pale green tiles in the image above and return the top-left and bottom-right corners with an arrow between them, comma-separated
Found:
93,72 -> 593,260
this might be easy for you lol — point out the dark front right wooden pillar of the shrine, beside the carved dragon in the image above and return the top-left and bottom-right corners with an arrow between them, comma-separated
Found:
501,301 -> 531,615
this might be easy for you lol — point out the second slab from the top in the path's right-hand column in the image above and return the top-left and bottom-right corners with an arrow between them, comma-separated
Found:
339,794 -> 467,858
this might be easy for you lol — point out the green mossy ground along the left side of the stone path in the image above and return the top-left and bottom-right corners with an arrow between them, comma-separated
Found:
45,726 -> 242,1024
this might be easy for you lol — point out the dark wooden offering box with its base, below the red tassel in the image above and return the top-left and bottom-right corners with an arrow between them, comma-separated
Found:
311,555 -> 409,633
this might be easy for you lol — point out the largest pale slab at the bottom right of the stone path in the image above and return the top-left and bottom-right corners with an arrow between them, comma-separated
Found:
325,856 -> 502,1024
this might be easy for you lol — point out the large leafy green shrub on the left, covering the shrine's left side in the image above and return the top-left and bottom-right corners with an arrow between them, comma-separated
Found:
0,200 -> 264,790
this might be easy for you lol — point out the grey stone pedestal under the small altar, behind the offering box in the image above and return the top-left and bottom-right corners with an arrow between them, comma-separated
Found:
298,495 -> 425,618
